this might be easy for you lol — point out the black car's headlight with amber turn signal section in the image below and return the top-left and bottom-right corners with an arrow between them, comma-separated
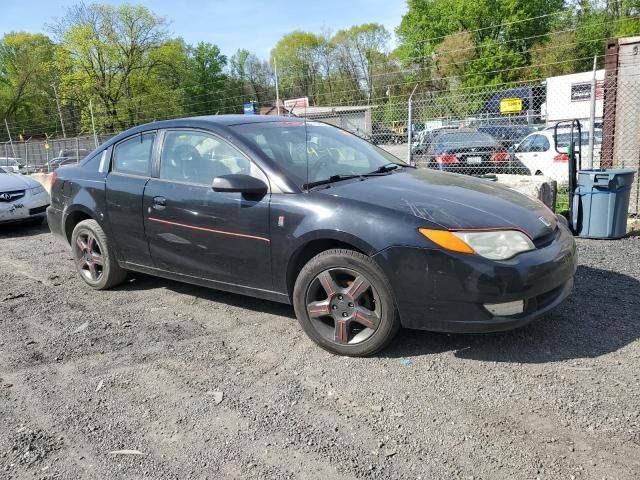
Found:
420,228 -> 536,260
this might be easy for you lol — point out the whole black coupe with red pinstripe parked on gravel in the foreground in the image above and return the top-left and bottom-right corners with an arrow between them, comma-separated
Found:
48,116 -> 576,355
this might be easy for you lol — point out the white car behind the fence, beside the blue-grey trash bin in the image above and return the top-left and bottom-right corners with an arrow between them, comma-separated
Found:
515,128 -> 602,184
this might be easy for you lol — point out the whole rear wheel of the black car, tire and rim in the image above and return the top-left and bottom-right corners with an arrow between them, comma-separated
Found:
71,220 -> 127,290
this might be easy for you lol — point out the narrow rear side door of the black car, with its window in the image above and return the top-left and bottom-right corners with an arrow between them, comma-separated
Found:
105,131 -> 156,266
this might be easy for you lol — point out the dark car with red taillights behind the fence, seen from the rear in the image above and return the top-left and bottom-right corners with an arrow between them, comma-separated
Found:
416,128 -> 528,175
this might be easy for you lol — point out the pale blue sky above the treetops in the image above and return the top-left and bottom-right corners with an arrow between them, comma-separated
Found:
0,0 -> 406,59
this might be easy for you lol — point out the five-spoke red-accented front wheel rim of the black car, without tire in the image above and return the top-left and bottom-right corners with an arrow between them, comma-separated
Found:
305,268 -> 382,345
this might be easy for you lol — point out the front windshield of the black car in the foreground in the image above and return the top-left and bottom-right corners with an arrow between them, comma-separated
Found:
232,119 -> 406,187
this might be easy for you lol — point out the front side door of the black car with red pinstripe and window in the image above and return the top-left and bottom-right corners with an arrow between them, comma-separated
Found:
144,129 -> 273,289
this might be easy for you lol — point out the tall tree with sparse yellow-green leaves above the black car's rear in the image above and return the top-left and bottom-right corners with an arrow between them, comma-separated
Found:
51,3 -> 174,131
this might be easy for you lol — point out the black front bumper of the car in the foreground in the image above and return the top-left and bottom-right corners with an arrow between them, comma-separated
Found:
374,226 -> 577,333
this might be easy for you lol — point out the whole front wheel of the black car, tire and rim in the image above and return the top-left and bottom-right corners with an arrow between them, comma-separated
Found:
293,249 -> 400,357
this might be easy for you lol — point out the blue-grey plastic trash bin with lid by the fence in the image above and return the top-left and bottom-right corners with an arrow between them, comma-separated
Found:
574,168 -> 635,239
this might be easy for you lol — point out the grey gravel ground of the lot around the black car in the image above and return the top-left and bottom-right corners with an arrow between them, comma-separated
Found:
0,222 -> 640,479
